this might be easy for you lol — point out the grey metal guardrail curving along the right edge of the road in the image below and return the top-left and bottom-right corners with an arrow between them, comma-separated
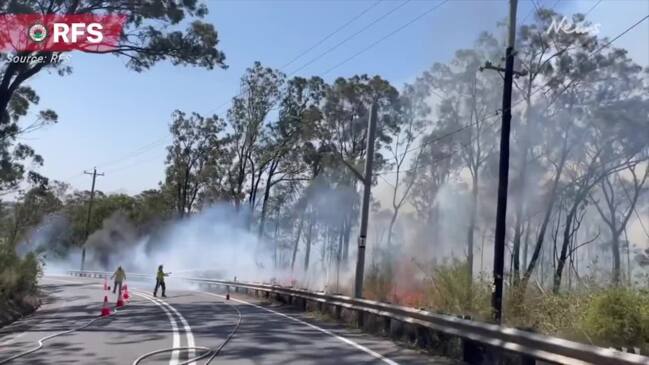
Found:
68,271 -> 649,365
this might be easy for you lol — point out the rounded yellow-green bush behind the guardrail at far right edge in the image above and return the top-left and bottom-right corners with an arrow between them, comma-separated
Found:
581,288 -> 649,350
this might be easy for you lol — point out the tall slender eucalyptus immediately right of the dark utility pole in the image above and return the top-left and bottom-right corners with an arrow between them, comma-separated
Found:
512,8 -> 597,284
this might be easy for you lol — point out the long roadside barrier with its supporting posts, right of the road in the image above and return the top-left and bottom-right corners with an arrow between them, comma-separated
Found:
68,271 -> 649,365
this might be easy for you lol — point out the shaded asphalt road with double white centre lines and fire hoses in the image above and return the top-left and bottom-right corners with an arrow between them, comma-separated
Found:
0,277 -> 457,365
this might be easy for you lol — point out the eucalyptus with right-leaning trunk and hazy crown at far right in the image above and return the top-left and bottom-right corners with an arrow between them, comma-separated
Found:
553,44 -> 649,292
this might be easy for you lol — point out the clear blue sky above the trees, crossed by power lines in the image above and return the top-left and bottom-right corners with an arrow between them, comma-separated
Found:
22,0 -> 649,194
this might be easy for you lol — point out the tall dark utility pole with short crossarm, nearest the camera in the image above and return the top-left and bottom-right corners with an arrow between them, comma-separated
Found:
480,0 -> 521,324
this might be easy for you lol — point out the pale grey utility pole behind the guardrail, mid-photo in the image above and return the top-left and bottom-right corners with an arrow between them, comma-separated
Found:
354,102 -> 377,298
